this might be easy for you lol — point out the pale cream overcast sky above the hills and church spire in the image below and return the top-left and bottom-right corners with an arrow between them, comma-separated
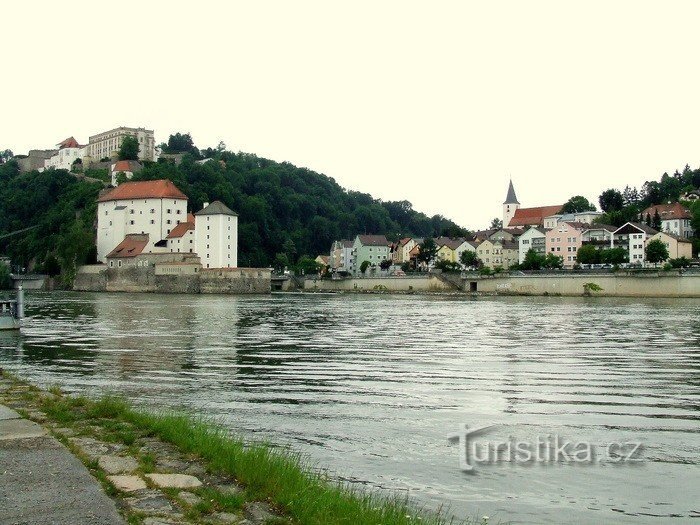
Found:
5,0 -> 700,228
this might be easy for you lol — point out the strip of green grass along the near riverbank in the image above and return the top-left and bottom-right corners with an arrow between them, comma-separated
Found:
5,374 -> 470,525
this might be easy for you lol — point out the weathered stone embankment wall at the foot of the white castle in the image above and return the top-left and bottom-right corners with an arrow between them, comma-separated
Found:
73,264 -> 270,294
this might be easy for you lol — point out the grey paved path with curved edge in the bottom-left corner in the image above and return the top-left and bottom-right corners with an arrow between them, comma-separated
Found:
0,400 -> 125,525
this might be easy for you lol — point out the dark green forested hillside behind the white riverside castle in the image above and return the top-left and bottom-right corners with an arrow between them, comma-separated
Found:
0,145 -> 466,271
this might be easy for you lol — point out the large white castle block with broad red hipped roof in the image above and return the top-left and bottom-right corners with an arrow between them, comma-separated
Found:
97,180 -> 187,262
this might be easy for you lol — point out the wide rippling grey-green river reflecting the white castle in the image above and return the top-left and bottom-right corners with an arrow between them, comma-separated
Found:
0,293 -> 700,524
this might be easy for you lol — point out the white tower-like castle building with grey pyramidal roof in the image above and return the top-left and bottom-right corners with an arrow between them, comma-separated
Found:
194,200 -> 238,268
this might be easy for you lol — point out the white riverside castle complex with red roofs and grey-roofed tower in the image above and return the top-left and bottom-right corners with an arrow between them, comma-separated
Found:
97,180 -> 238,268
